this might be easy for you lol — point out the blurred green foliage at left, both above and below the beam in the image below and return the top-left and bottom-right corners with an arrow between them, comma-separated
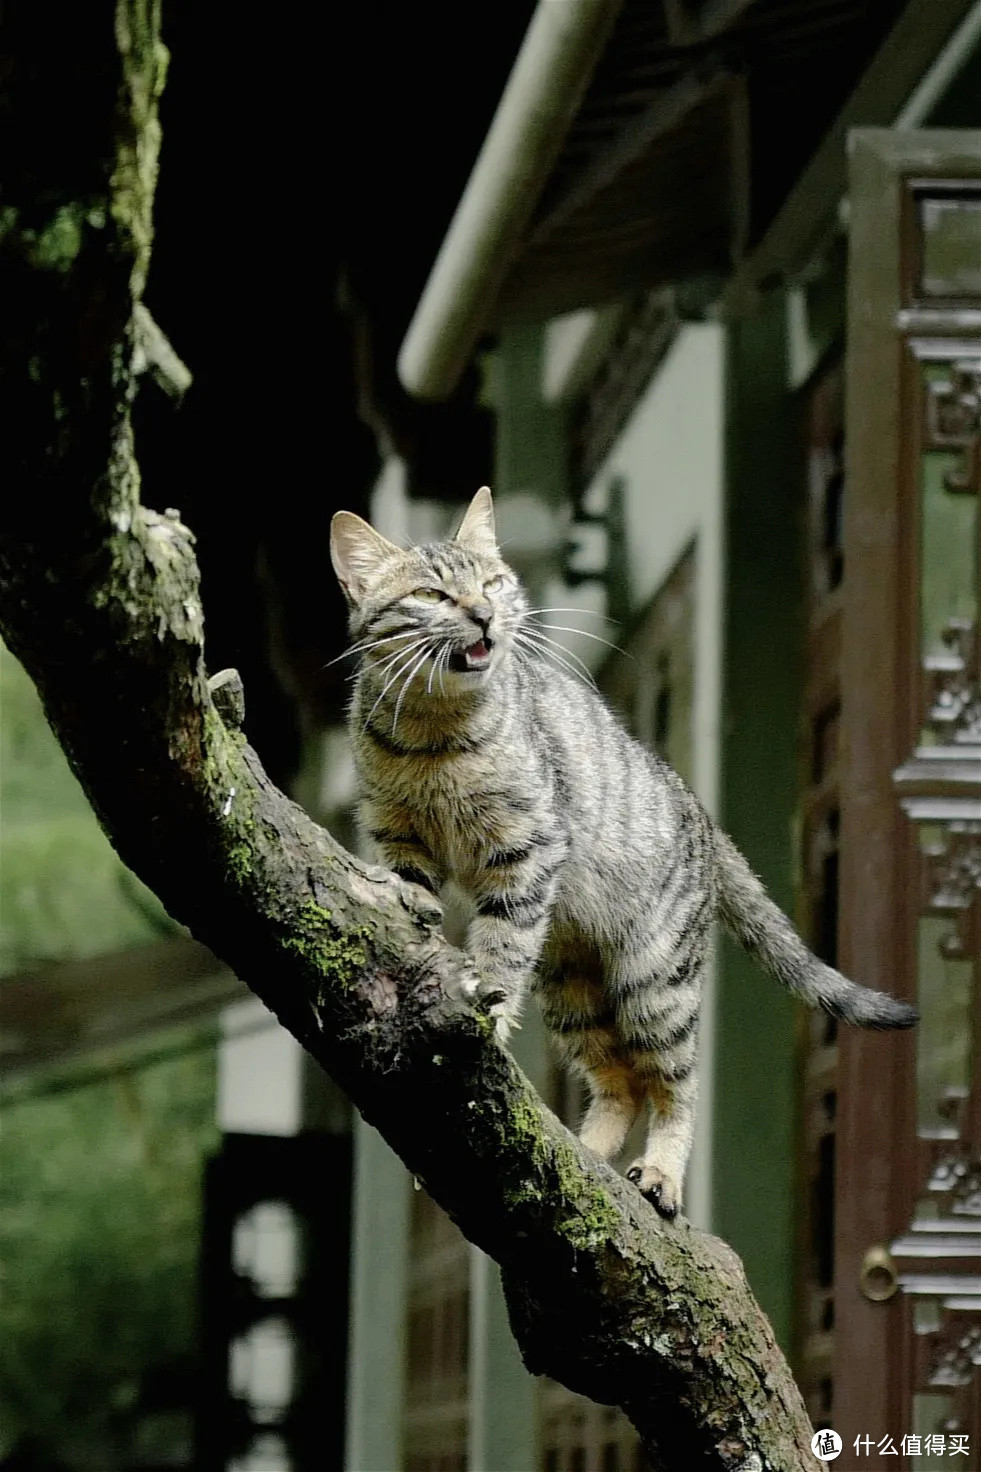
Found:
0,646 -> 218,1472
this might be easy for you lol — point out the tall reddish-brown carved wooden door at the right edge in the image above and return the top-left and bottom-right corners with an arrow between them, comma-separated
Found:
834,130 -> 981,1472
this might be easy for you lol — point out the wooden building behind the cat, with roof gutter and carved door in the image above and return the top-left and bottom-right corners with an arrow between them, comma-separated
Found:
340,0 -> 981,1472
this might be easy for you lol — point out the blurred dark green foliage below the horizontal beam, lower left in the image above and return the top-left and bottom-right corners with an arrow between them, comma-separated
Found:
0,1032 -> 218,1472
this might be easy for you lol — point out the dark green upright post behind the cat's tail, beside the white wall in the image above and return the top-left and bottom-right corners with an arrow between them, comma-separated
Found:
713,291 -> 804,1348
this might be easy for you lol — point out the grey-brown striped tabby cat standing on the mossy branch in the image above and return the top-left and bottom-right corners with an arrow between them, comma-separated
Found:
330,486 -> 916,1217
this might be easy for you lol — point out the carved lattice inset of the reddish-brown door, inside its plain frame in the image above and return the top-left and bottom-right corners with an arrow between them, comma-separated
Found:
891,337 -> 981,1436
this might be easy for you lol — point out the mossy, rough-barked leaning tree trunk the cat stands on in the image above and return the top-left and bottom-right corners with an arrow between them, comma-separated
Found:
0,0 -> 816,1472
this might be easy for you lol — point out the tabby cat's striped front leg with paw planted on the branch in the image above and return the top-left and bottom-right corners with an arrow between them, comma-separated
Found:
467,843 -> 558,1042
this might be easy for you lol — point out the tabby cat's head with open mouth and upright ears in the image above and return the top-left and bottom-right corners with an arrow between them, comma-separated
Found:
330,486 -> 527,692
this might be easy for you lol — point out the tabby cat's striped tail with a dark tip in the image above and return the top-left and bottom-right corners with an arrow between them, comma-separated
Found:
713,829 -> 919,1027
